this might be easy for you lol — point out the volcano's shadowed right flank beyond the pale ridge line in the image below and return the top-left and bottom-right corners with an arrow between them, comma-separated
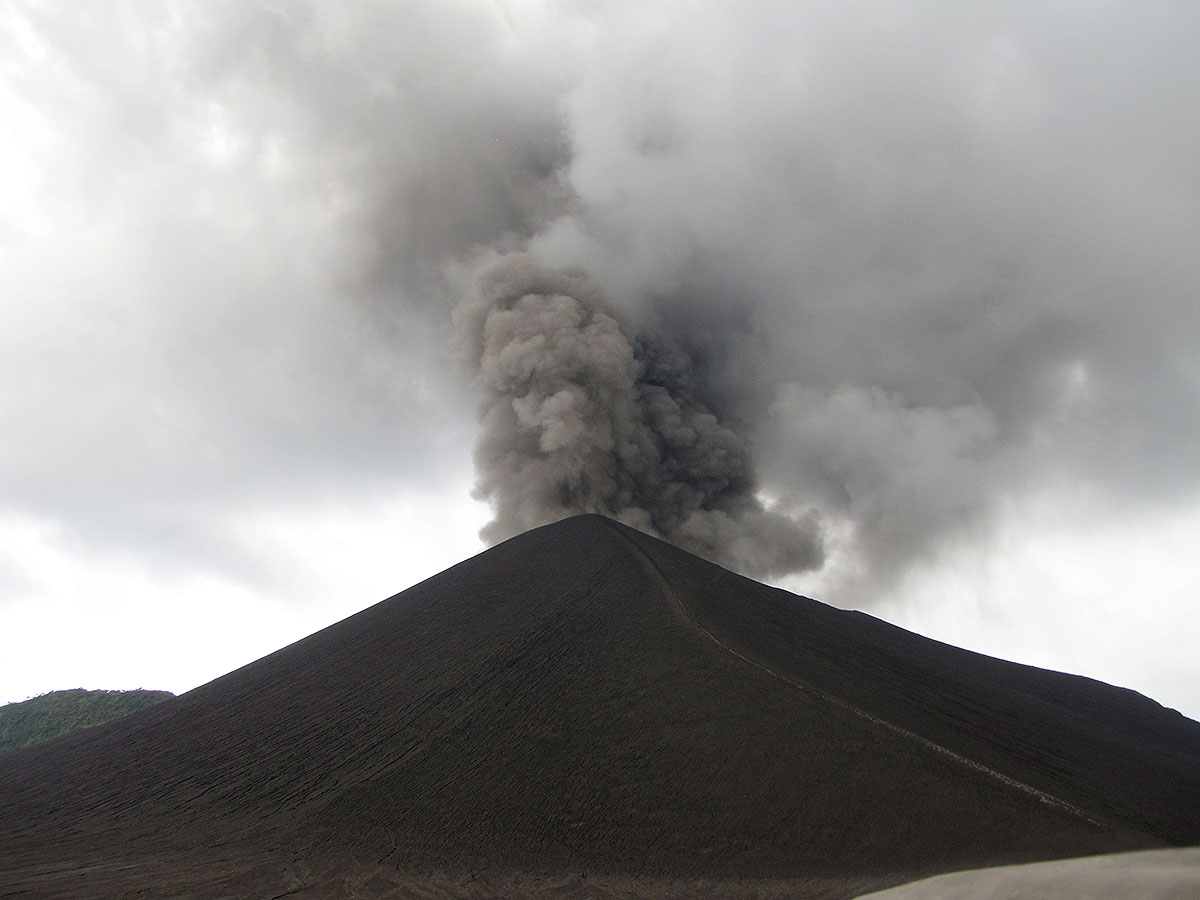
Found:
630,533 -> 1200,845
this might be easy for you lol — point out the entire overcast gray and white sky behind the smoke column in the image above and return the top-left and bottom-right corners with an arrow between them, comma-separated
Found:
0,0 -> 1200,718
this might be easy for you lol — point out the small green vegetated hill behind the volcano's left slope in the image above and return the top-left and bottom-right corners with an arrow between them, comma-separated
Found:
0,688 -> 175,752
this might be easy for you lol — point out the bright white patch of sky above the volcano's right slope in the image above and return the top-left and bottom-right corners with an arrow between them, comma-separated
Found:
854,496 -> 1200,719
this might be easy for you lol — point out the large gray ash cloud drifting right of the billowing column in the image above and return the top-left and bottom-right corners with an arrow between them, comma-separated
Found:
532,4 -> 1200,604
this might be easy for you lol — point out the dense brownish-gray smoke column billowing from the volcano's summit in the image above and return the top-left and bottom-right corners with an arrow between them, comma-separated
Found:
456,256 -> 823,577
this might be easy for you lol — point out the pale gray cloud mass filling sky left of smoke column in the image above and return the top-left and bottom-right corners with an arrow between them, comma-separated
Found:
0,2 -> 563,572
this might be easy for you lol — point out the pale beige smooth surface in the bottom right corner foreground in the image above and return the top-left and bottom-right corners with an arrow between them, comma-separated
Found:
860,847 -> 1200,900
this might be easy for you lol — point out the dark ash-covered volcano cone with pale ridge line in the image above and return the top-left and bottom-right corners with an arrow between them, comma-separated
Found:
0,516 -> 1200,898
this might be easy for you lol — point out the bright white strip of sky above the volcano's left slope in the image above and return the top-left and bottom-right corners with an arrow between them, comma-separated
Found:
0,484 -> 486,702
